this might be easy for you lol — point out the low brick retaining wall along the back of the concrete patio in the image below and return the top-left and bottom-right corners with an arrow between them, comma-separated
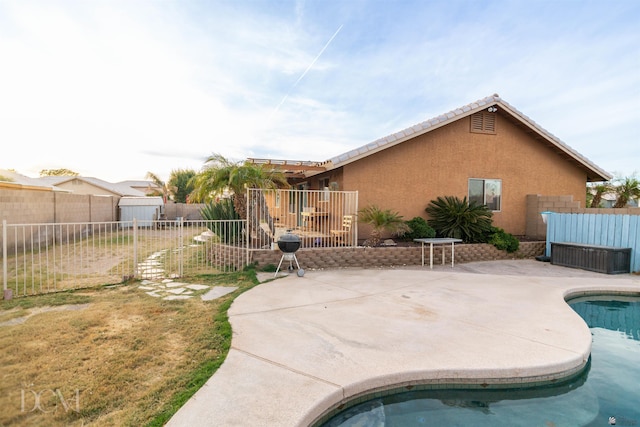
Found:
251,242 -> 545,269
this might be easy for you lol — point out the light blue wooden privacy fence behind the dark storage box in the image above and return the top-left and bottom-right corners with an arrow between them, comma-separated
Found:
546,213 -> 640,272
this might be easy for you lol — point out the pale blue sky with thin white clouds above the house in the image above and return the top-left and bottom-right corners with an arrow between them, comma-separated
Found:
0,0 -> 640,182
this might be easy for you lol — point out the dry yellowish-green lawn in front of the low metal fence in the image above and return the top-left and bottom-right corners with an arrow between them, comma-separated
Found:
0,270 -> 257,426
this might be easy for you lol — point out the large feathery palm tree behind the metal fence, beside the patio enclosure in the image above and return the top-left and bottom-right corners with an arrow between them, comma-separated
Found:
190,154 -> 289,219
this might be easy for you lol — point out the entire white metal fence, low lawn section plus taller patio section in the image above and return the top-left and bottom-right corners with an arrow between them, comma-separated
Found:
1,189 -> 358,296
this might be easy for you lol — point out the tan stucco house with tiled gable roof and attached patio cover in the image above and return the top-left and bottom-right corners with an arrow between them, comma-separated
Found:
249,94 -> 611,239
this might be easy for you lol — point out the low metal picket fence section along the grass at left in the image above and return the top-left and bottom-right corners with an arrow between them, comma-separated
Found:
1,220 -> 248,296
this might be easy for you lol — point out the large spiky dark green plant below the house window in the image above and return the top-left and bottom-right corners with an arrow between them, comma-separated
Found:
425,196 -> 492,243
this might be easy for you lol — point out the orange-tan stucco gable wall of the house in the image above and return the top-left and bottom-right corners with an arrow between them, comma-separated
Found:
340,113 -> 586,235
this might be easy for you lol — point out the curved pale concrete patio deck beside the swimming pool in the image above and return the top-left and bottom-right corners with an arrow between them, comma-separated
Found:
168,260 -> 640,426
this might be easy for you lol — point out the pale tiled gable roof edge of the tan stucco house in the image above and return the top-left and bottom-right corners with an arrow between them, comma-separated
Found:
323,94 -> 612,182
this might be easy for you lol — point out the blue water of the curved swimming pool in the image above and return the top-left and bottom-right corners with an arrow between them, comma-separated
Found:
323,296 -> 640,427
